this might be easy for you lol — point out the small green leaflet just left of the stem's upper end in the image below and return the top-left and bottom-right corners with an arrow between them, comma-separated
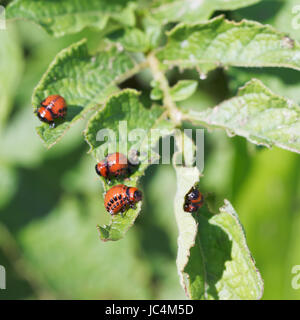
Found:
108,28 -> 149,52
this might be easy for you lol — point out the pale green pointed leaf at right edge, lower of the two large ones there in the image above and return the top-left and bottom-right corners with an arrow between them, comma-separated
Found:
183,79 -> 300,153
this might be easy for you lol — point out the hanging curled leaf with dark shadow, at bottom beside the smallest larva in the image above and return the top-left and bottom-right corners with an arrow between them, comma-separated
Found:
174,136 -> 263,300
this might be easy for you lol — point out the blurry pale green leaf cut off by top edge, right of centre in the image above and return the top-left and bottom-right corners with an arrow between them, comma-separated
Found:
151,0 -> 260,23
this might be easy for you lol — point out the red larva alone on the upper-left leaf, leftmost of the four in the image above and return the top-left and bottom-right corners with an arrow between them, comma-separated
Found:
35,94 -> 67,128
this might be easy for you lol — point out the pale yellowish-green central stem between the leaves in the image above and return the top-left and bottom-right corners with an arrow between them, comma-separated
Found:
147,53 -> 182,126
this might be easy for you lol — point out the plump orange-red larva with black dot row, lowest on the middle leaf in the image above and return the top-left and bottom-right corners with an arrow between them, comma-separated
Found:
104,184 -> 142,215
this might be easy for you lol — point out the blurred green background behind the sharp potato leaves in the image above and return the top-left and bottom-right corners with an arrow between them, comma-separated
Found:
0,1 -> 300,299
